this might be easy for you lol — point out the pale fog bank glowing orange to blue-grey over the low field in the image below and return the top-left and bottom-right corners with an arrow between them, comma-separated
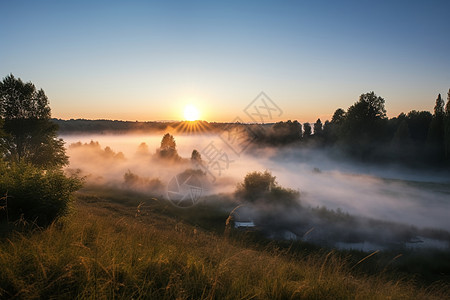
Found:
61,134 -> 450,230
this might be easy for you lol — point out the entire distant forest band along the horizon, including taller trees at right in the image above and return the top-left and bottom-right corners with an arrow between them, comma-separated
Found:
53,90 -> 450,169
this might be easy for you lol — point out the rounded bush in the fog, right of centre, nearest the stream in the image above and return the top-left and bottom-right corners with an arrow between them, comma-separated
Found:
235,170 -> 299,204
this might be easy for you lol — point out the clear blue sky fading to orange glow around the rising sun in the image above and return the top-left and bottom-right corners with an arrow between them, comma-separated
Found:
0,0 -> 450,122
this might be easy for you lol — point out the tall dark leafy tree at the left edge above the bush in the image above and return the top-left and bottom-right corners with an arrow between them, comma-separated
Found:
0,74 -> 68,169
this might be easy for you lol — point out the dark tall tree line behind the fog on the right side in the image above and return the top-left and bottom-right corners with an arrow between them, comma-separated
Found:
256,90 -> 450,166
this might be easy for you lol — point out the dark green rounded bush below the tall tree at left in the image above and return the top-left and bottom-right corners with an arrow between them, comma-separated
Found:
0,161 -> 81,226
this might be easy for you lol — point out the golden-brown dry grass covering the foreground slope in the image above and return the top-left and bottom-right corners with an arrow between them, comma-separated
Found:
0,186 -> 449,299
